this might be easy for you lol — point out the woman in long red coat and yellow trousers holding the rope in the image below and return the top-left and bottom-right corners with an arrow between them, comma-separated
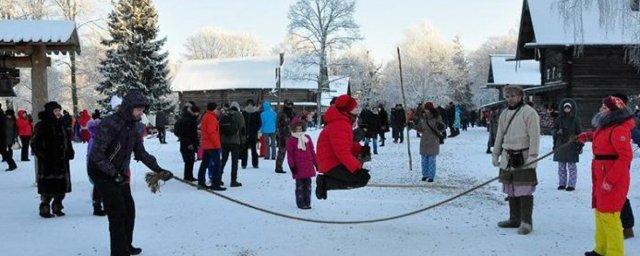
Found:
577,96 -> 635,256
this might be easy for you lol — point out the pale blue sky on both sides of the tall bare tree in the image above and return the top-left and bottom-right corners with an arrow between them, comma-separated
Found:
155,0 -> 522,60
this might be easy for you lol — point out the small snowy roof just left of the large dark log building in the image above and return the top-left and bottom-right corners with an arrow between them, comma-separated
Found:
488,54 -> 541,86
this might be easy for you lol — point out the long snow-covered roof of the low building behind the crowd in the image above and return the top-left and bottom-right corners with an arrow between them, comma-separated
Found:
171,56 -> 348,92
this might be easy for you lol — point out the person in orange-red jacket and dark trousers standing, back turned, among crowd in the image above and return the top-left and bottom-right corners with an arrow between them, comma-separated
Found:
198,102 -> 226,191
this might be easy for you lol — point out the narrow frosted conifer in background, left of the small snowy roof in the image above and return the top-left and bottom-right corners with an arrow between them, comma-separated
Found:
449,36 -> 473,109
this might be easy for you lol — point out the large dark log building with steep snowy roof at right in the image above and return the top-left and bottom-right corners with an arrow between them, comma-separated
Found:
515,0 -> 640,128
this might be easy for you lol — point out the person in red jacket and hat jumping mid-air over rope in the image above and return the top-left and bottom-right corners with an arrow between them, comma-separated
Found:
316,95 -> 371,199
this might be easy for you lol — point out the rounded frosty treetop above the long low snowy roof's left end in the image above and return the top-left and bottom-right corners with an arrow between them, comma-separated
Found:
184,27 -> 263,59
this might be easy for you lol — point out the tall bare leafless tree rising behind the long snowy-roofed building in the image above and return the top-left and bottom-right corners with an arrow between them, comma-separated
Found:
288,0 -> 362,121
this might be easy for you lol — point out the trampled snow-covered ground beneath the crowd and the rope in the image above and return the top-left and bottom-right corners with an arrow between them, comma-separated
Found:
0,128 -> 640,255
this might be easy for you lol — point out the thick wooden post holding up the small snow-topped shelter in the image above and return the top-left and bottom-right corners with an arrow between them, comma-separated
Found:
31,45 -> 49,123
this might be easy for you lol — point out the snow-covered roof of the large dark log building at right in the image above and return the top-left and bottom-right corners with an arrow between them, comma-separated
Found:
517,0 -> 638,59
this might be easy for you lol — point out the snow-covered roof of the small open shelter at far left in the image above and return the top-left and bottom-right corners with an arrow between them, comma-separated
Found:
0,20 -> 79,53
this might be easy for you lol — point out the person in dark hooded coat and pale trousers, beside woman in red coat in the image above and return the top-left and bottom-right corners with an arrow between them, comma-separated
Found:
552,99 -> 584,191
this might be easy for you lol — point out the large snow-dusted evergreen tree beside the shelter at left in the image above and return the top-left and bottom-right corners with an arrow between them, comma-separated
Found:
96,0 -> 174,111
